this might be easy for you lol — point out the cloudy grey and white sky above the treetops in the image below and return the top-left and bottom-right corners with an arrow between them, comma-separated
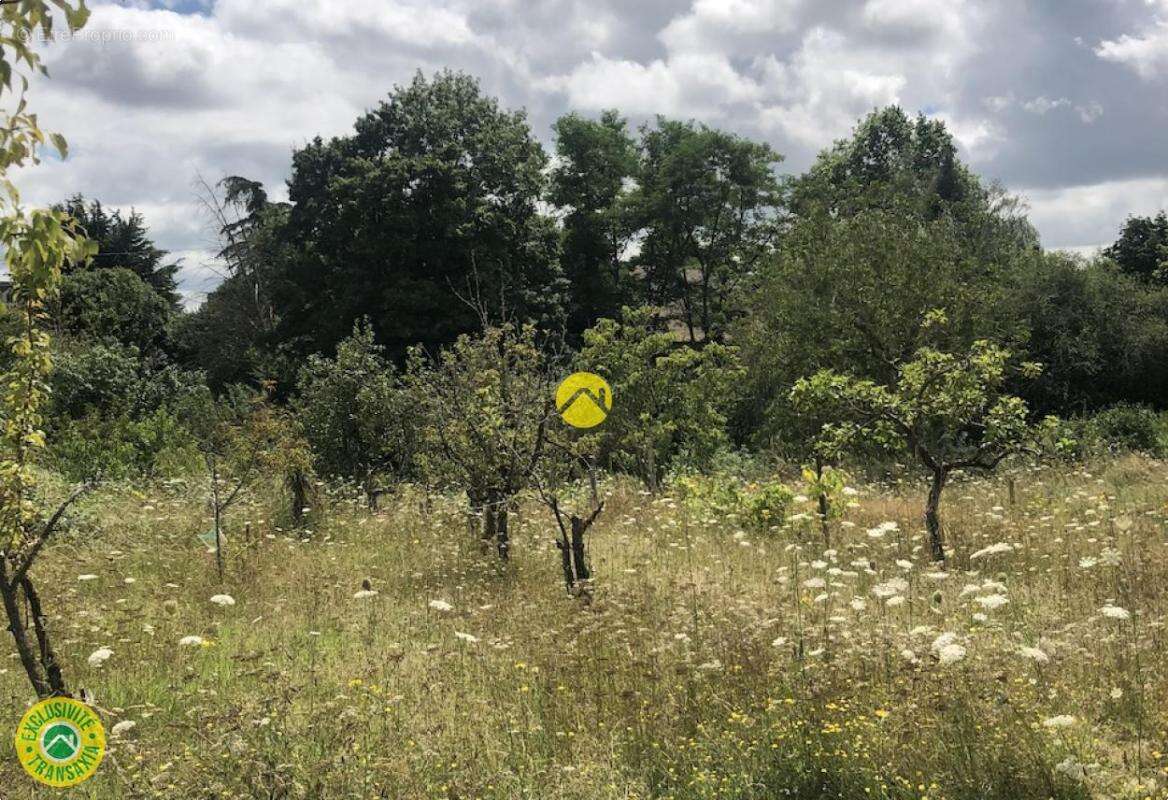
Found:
15,0 -> 1168,302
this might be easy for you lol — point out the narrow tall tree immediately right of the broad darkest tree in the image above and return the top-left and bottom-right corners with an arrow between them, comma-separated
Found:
548,111 -> 638,336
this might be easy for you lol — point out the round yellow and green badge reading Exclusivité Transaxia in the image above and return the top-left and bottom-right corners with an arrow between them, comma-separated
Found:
16,697 -> 105,788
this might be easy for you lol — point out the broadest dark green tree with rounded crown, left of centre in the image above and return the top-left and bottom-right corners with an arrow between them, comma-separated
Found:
281,71 -> 563,356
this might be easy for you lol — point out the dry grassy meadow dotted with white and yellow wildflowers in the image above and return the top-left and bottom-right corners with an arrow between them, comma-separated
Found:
0,457 -> 1168,800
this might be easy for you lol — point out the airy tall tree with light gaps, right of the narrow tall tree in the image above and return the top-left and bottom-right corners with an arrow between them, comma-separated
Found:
634,118 -> 781,342
